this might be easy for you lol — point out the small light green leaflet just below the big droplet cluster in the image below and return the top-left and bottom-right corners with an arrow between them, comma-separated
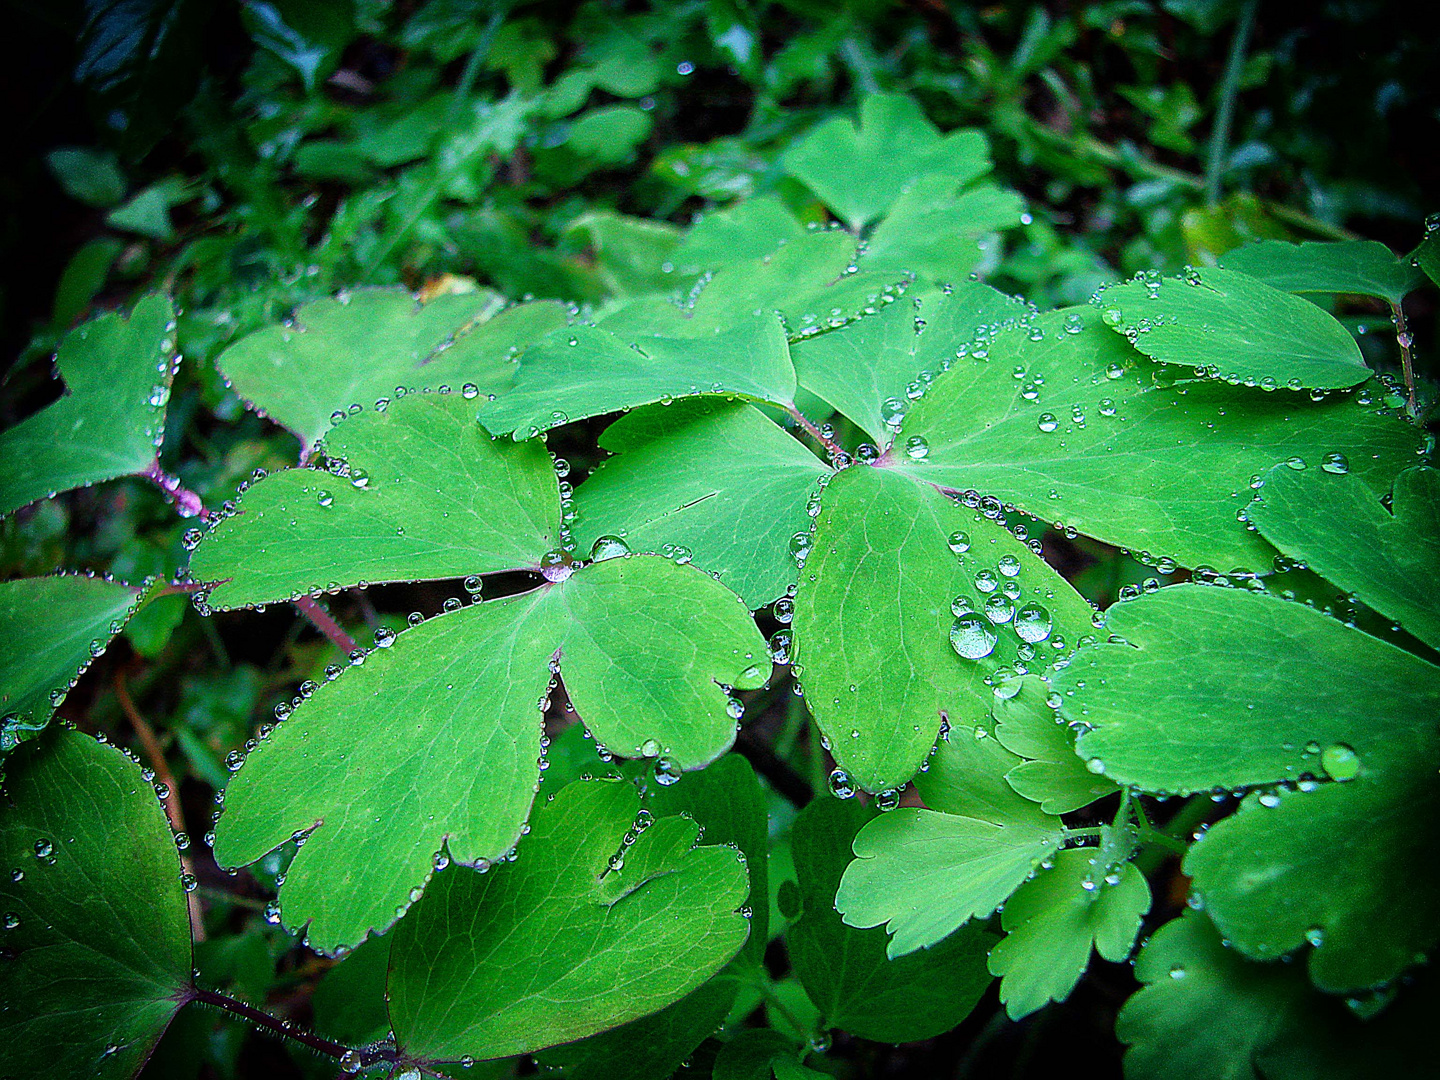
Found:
991,675 -> 1119,815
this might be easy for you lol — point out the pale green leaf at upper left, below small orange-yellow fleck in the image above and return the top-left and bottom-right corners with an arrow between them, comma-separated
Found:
216,289 -> 509,448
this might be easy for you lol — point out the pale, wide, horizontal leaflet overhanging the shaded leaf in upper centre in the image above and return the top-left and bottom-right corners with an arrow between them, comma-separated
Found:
480,314 -> 795,438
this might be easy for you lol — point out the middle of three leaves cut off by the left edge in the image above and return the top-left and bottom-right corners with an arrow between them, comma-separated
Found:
0,575 -> 144,753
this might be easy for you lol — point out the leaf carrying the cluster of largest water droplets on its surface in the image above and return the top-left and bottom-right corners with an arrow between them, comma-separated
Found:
795,465 -> 1090,792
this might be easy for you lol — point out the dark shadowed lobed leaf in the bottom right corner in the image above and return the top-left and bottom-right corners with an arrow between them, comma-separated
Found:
1115,912 -> 1440,1080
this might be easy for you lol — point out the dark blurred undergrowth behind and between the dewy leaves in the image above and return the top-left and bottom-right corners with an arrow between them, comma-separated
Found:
0,0 -> 1440,1077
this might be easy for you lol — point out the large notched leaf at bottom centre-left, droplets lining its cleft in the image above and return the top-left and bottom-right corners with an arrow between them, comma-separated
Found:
389,780 -> 749,1061
